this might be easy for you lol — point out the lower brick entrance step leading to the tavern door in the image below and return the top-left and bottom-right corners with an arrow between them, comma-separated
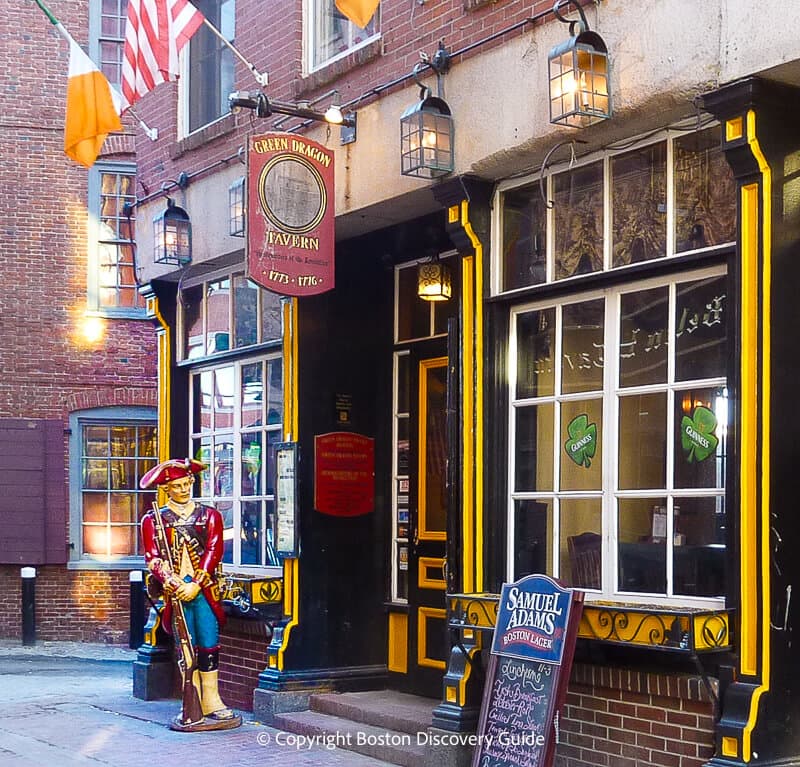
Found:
273,711 -> 425,767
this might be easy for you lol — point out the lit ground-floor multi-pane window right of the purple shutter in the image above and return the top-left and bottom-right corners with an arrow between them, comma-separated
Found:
73,418 -> 157,562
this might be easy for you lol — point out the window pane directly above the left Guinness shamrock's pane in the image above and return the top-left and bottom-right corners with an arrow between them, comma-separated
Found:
561,298 -> 605,394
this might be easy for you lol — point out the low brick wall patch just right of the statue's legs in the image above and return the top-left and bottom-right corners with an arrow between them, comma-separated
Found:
219,619 -> 269,711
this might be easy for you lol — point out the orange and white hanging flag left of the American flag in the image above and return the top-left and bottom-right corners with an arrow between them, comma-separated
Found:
65,31 -> 122,168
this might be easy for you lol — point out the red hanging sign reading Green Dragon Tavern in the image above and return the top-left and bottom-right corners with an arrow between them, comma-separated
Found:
247,133 -> 335,296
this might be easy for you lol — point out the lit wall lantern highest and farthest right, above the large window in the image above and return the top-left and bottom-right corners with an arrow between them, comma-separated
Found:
547,0 -> 612,128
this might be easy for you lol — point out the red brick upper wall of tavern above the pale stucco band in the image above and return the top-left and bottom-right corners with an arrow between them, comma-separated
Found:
136,0 -> 559,189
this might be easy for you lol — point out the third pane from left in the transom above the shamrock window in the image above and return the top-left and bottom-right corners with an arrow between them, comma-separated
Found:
611,141 -> 667,267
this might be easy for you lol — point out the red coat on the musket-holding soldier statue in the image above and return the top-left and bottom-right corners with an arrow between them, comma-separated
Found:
142,504 -> 225,631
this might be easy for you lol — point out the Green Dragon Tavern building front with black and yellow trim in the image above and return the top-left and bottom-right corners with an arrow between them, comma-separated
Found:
14,0 -> 800,767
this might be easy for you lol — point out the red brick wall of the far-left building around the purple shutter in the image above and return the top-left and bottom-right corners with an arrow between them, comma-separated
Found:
0,0 -> 156,642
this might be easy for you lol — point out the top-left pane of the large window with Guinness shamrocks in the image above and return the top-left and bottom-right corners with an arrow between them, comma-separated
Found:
517,308 -> 556,399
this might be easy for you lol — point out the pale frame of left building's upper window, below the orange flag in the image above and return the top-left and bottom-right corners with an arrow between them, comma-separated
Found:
86,162 -> 147,319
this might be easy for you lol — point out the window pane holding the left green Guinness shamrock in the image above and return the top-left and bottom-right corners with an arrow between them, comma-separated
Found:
560,399 -> 603,490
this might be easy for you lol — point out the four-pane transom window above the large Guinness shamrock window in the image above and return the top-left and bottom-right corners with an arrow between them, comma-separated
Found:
494,126 -> 736,292
